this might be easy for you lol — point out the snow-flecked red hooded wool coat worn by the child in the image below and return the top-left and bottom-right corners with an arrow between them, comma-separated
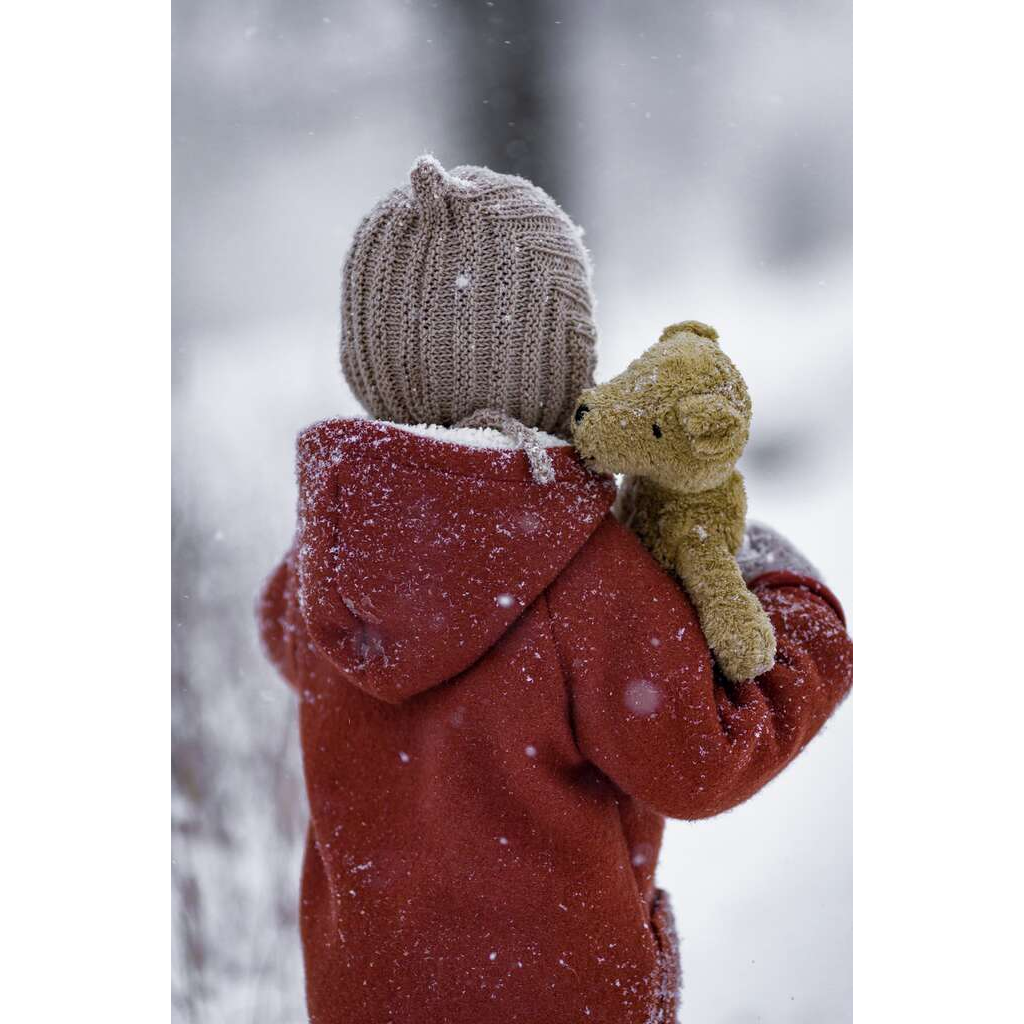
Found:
261,420 -> 851,1024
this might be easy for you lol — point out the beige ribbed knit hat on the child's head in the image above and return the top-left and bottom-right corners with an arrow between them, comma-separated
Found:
341,156 -> 595,435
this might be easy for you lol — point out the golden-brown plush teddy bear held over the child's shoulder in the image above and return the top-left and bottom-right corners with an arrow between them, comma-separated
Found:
572,321 -> 775,682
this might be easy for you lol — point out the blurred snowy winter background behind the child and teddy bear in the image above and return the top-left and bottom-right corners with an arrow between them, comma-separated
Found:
173,0 -> 855,1024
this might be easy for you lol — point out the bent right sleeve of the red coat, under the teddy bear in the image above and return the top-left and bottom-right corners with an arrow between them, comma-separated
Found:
549,519 -> 852,819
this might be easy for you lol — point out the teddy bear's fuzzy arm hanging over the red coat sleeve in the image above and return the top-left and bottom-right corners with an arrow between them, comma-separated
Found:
675,543 -> 775,682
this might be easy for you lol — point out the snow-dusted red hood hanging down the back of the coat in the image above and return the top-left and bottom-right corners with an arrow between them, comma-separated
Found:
296,420 -> 615,702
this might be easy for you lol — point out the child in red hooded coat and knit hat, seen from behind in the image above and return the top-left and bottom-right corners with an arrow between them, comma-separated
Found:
260,158 -> 851,1024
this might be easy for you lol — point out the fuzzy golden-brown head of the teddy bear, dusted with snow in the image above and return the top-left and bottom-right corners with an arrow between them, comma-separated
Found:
572,321 -> 751,492
